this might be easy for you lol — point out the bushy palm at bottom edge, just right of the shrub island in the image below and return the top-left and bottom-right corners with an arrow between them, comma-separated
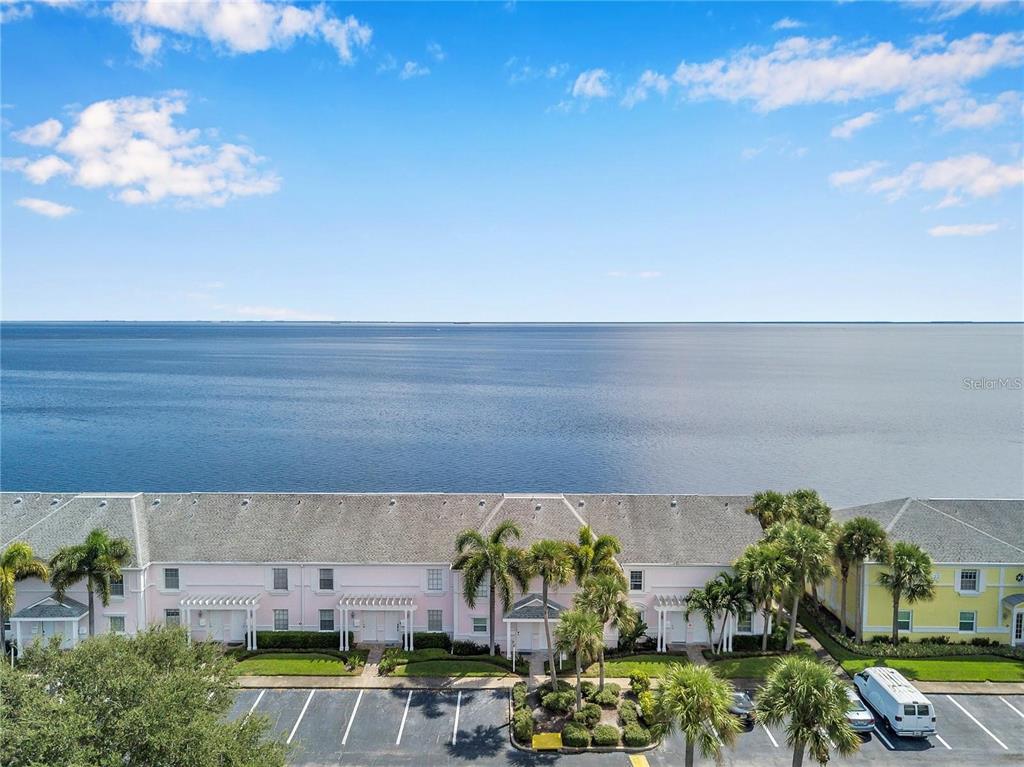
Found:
657,664 -> 739,767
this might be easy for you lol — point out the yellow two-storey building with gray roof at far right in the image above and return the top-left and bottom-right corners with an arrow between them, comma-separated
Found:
817,498 -> 1024,646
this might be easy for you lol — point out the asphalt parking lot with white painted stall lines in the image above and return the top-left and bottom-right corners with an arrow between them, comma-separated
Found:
230,689 -> 1024,767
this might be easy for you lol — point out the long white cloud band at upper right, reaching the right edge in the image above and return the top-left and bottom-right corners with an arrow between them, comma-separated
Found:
674,32 -> 1024,112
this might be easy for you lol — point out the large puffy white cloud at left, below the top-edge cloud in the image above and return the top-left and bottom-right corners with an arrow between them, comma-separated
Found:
5,93 -> 281,206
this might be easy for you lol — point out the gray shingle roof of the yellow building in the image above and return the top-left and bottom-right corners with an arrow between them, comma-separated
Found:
835,498 -> 1024,564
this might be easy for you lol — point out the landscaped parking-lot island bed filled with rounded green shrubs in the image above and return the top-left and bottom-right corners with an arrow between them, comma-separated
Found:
511,672 -> 657,752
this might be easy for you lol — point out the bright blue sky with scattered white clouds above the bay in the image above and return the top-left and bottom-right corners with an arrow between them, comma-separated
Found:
0,0 -> 1024,322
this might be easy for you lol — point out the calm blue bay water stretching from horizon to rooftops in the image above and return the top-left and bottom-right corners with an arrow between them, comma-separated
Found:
0,323 -> 1024,505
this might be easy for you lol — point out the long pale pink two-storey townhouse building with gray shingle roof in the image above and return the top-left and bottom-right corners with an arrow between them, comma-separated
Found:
0,493 -> 762,654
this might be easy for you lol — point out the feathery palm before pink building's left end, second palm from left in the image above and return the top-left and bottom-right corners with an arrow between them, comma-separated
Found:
50,527 -> 132,637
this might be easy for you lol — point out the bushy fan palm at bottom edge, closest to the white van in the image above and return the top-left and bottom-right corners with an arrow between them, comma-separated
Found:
755,655 -> 860,767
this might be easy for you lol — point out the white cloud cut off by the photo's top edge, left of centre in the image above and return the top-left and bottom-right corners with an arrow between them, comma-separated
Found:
110,0 -> 373,62
